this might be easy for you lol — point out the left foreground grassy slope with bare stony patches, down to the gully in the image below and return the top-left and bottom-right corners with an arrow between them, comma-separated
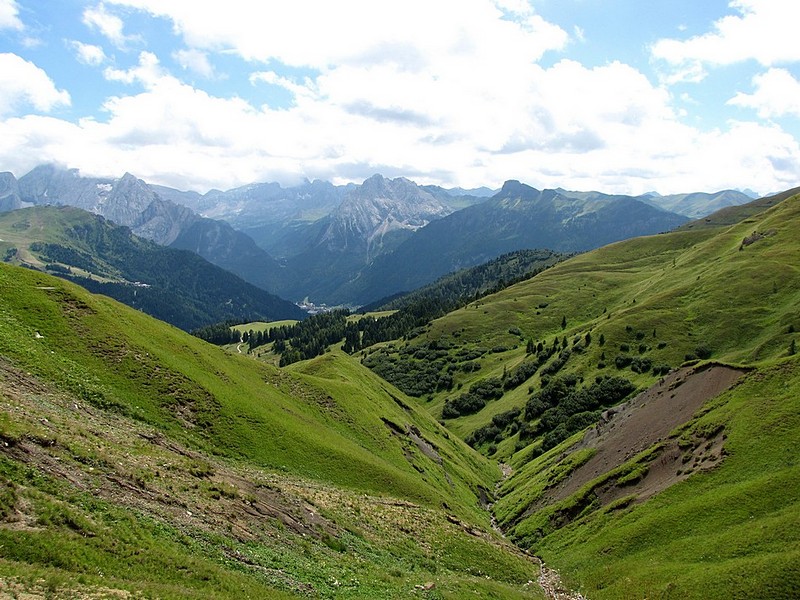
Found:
0,265 -> 536,598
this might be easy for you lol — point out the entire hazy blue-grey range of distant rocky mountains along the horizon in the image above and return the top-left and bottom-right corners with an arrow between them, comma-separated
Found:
0,165 -> 749,305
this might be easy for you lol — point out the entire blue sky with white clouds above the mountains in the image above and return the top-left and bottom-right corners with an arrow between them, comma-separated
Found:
0,0 -> 800,195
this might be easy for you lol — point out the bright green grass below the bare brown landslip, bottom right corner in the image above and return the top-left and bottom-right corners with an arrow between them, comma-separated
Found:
510,357 -> 800,600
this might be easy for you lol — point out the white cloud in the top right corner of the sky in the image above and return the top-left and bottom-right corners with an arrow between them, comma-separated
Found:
651,0 -> 800,80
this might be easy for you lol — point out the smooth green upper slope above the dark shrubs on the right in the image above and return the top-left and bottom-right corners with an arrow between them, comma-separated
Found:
388,196 -> 800,440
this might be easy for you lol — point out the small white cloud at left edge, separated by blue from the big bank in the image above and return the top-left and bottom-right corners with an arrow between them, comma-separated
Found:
0,53 -> 70,115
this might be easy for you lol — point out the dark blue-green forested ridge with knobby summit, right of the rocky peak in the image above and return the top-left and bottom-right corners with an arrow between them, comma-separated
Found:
343,181 -> 688,301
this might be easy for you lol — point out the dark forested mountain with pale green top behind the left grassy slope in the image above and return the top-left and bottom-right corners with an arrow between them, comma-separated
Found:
0,206 -> 306,330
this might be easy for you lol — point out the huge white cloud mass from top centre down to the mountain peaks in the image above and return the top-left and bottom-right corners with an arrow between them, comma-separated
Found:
0,0 -> 800,193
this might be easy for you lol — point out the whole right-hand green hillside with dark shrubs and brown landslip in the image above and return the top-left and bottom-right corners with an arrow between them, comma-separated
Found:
362,189 -> 800,598
